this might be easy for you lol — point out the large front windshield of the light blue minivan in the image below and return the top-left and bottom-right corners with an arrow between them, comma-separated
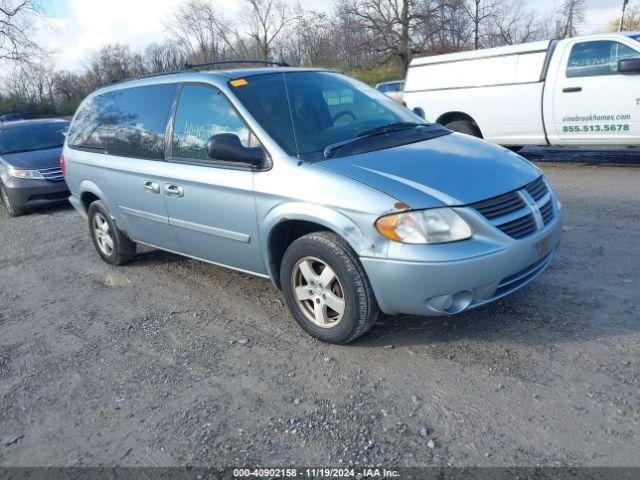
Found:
230,71 -> 444,158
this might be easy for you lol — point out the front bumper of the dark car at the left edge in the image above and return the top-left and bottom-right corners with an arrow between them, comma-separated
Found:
1,172 -> 70,210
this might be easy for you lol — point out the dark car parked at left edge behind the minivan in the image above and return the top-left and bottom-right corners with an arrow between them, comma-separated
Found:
0,119 -> 69,217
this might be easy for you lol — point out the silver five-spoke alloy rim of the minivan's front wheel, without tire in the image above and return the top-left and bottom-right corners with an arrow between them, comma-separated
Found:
291,257 -> 346,328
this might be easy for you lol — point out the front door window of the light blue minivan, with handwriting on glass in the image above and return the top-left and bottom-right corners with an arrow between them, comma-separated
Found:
172,85 -> 256,162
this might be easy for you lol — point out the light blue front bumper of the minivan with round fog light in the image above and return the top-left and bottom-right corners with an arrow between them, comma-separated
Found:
361,200 -> 563,316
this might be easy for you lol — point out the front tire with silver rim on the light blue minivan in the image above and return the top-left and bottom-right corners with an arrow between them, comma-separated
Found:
280,232 -> 379,344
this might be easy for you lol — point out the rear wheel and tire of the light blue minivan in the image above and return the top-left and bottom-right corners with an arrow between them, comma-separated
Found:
87,200 -> 137,266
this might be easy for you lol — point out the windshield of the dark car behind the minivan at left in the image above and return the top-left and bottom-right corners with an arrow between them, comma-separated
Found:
0,122 -> 69,154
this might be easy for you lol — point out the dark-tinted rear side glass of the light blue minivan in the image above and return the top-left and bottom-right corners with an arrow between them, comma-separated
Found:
69,84 -> 176,160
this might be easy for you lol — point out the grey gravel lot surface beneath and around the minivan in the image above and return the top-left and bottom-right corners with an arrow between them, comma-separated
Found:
0,150 -> 640,466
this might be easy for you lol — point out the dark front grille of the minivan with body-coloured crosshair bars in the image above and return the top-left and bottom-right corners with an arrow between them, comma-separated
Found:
471,177 -> 554,239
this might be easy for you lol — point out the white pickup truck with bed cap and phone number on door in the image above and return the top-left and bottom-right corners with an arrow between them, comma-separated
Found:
403,32 -> 640,148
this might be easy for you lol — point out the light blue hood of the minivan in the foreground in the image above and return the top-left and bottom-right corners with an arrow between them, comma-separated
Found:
317,133 -> 541,209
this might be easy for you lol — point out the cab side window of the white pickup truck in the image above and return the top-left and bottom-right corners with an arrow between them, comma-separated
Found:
567,40 -> 640,78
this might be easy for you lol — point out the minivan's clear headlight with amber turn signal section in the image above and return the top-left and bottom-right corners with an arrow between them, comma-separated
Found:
376,208 -> 473,244
